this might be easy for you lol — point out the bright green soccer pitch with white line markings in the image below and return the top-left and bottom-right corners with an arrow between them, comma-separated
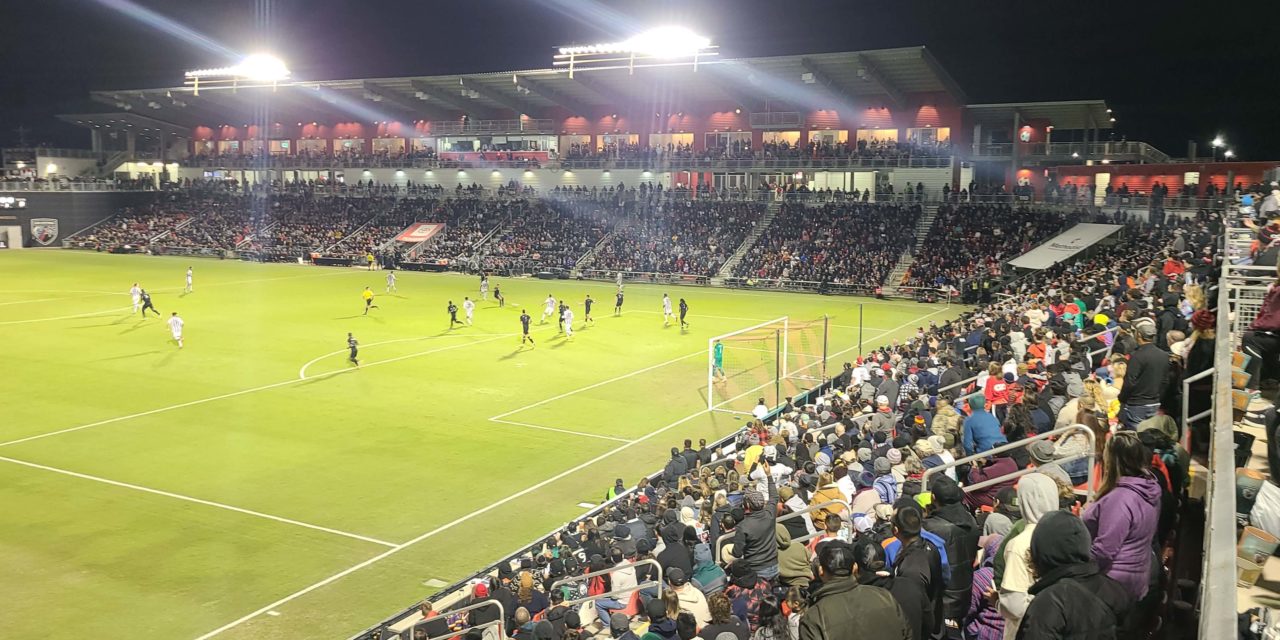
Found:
0,251 -> 960,640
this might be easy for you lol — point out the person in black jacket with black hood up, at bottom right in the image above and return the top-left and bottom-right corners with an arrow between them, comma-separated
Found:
1016,511 -> 1133,640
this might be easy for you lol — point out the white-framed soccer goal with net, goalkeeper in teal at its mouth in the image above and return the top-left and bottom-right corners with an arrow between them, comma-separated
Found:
707,316 -> 828,413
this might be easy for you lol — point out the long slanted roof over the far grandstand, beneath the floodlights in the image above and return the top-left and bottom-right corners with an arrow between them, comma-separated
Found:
74,46 -> 964,127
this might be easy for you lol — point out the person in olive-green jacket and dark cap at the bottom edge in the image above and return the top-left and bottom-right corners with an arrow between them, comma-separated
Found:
799,541 -> 913,640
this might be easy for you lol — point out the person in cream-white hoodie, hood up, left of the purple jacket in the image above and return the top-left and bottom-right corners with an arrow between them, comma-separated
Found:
998,474 -> 1059,640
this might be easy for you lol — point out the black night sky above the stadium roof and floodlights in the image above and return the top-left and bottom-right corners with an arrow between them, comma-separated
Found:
0,0 -> 1280,160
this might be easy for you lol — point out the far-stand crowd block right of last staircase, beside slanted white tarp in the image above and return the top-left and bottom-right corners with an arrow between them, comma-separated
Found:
904,204 -> 1088,287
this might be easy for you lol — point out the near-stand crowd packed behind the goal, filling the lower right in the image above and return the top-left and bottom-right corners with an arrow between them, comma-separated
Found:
413,203 -> 1223,640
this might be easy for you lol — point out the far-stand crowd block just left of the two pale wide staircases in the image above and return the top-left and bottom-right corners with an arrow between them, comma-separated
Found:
590,200 -> 764,276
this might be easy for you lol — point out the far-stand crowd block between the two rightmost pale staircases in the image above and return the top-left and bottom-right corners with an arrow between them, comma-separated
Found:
735,202 -> 922,287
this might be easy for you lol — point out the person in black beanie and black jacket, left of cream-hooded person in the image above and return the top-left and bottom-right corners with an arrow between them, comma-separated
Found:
924,476 -> 979,621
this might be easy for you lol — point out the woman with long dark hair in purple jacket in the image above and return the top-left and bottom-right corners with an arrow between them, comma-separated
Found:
1083,431 -> 1161,602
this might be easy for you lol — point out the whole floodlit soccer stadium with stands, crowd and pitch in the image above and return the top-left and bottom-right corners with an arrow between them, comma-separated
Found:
0,6 -> 1280,640
